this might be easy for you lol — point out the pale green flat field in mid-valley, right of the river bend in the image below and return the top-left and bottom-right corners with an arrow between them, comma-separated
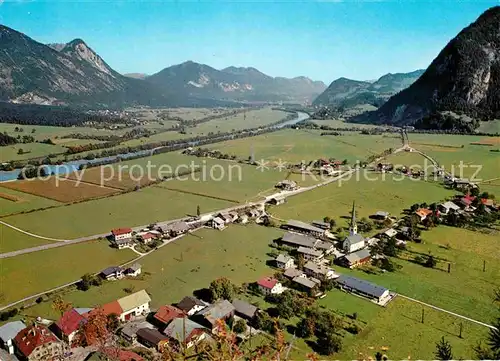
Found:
210,129 -> 401,163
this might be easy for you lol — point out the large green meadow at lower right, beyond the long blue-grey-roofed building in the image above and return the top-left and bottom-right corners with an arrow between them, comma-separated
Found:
338,226 -> 500,323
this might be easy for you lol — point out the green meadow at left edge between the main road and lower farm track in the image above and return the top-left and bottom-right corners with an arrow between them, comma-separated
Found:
0,241 -> 136,304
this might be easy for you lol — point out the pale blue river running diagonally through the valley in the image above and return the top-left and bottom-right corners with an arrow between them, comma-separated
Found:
0,112 -> 309,182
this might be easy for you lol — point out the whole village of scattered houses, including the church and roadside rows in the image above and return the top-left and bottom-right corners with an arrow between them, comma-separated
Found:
0,168 -> 500,361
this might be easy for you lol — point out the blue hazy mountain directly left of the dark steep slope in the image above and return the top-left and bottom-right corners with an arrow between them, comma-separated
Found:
313,70 -> 424,107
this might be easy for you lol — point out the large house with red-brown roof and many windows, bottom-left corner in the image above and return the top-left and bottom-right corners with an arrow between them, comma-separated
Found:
14,324 -> 67,361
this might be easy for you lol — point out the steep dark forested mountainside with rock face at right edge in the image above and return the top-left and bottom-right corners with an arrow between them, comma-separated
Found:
369,6 -> 500,127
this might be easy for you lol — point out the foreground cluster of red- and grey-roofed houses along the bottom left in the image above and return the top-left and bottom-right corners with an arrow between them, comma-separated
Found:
0,290 -> 266,361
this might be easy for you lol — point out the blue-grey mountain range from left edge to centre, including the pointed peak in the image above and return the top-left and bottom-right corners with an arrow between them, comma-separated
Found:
0,25 -> 326,107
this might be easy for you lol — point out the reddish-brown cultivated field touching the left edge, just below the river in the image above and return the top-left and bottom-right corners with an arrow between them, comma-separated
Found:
0,177 -> 118,203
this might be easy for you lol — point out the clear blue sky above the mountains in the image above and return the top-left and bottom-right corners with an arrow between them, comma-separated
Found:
0,0 -> 499,83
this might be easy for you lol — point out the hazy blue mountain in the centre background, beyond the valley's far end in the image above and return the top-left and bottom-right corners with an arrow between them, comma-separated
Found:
146,61 -> 326,102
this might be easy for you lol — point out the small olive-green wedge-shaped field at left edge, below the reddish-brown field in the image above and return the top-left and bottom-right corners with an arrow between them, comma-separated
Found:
0,187 -> 61,216
